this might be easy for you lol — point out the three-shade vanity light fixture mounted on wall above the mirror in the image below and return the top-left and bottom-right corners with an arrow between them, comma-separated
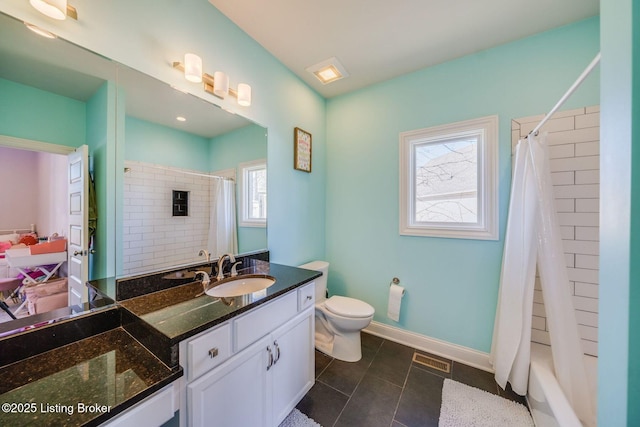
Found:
173,53 -> 251,107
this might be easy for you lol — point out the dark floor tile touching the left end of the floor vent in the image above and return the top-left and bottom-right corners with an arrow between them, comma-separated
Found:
368,341 -> 414,387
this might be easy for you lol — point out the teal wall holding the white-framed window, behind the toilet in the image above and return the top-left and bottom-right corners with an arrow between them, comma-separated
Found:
326,18 -> 599,352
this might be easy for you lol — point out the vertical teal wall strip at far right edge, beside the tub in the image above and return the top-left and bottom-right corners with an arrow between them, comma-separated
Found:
598,0 -> 640,427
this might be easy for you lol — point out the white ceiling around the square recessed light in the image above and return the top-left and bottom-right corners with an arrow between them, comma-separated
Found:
209,0 -> 599,98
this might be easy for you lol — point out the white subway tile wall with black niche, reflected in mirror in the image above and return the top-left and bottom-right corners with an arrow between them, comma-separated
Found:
123,161 -> 210,275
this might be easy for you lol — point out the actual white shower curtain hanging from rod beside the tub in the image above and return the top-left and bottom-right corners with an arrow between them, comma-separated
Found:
491,135 -> 595,425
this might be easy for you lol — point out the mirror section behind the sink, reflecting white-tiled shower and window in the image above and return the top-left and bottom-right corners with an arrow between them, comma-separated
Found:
117,66 -> 267,277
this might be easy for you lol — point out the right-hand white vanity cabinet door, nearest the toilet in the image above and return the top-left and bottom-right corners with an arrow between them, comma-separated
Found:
269,307 -> 315,426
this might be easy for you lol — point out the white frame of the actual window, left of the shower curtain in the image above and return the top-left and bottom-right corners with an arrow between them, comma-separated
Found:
400,116 -> 499,240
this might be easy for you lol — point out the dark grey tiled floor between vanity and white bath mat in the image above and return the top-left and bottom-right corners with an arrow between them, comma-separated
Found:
297,333 -> 526,427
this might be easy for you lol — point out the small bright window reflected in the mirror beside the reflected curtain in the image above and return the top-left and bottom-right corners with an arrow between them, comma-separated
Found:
239,159 -> 267,227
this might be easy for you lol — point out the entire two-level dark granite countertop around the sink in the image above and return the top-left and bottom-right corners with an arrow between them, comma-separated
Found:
0,260 -> 321,426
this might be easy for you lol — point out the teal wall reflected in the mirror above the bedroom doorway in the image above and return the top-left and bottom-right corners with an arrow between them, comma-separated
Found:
0,79 -> 86,147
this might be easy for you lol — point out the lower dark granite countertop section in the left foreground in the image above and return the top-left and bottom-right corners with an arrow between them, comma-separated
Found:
0,320 -> 182,426
